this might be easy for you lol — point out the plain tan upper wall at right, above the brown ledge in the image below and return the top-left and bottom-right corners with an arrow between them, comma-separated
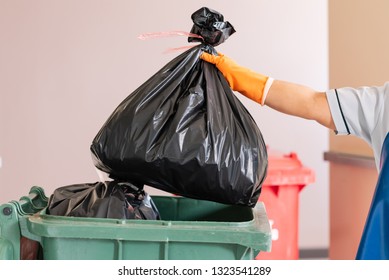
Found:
329,0 -> 389,158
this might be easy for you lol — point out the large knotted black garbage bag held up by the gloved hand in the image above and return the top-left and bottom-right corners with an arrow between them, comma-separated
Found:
91,8 -> 267,206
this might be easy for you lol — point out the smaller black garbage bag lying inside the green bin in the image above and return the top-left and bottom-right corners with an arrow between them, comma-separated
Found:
47,181 -> 160,220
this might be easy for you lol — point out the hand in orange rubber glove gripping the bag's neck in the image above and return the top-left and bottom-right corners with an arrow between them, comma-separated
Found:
200,52 -> 273,105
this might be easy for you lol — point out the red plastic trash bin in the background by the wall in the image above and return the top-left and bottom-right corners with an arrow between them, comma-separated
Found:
256,150 -> 315,260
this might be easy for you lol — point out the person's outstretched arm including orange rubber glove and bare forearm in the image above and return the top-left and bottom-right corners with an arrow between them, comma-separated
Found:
201,53 -> 335,129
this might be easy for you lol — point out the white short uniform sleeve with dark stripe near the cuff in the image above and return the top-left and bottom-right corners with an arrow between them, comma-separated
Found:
327,84 -> 389,146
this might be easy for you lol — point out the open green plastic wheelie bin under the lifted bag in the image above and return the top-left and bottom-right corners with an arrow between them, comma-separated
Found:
0,187 -> 271,260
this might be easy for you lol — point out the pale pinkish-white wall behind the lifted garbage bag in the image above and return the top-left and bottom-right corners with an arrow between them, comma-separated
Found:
0,0 -> 328,248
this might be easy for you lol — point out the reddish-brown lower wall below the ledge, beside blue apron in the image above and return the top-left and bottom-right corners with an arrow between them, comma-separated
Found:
329,162 -> 377,260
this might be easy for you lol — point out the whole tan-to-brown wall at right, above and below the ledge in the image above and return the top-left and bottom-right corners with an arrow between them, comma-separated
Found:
329,0 -> 389,259
